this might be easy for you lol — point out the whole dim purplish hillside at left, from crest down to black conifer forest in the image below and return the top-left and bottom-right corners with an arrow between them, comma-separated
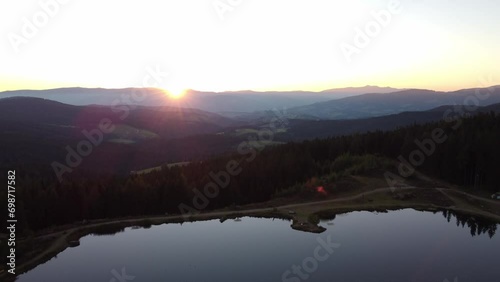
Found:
0,97 -> 247,173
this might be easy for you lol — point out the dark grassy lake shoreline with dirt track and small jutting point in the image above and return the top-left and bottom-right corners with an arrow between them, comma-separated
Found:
4,187 -> 500,281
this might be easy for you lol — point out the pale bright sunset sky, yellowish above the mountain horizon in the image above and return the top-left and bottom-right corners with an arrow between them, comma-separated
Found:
0,0 -> 500,92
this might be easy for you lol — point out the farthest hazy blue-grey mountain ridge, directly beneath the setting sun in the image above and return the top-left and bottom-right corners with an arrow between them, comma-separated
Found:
0,86 -> 398,113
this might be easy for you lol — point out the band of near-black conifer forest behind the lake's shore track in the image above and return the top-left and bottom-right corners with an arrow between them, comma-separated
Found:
1,113 -> 500,234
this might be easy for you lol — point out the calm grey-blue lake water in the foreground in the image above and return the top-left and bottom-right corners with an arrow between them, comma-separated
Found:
18,209 -> 500,282
